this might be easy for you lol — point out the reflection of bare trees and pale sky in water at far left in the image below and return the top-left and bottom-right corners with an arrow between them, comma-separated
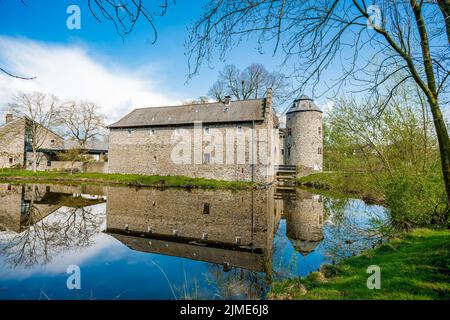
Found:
1,185 -> 105,268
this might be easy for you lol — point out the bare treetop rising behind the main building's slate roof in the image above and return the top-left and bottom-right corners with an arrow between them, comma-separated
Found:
208,63 -> 287,106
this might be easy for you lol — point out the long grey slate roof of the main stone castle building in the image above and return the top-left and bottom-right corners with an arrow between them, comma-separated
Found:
108,99 -> 266,129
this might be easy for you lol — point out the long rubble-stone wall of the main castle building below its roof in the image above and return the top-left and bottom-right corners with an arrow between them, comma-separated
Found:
108,123 -> 275,183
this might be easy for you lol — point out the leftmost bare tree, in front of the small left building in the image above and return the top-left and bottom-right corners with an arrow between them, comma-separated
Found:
9,92 -> 60,172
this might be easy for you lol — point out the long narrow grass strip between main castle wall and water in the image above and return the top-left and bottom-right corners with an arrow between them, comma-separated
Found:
0,170 -> 255,189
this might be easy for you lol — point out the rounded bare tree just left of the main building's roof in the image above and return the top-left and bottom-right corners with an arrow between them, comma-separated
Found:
60,101 -> 105,149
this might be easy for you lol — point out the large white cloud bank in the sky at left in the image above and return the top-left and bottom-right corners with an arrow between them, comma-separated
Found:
0,36 -> 174,121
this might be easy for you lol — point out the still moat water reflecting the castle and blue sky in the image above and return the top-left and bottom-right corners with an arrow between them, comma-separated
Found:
0,184 -> 387,300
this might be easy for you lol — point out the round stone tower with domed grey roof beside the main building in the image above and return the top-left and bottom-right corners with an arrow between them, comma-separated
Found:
285,95 -> 323,176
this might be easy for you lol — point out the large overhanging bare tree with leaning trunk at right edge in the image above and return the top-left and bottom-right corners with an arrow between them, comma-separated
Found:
186,0 -> 450,202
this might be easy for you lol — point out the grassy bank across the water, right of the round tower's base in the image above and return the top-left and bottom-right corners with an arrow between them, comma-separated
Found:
296,172 -> 384,203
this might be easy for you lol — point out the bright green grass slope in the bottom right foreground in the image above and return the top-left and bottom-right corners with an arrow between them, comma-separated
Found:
269,229 -> 450,300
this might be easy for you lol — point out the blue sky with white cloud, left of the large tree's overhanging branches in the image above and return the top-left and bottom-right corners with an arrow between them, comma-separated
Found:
0,0 -> 298,119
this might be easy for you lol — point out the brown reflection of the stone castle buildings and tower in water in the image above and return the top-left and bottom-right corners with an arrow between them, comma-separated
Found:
0,184 -> 324,278
